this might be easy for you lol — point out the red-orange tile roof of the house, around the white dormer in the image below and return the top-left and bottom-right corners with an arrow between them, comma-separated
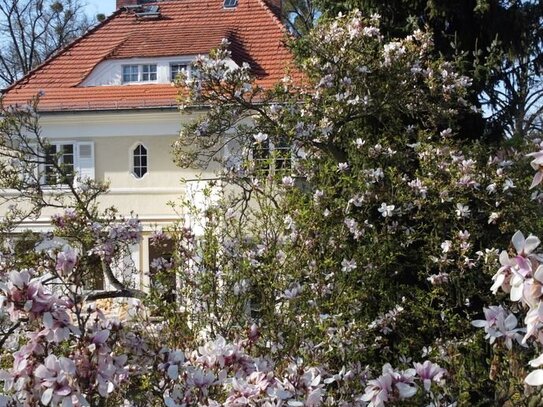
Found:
4,0 -> 298,111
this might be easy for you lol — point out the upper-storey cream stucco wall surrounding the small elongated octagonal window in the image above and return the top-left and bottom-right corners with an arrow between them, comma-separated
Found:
37,110 -> 214,222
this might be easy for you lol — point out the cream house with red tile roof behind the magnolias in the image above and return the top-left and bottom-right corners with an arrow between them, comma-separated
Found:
3,0 -> 298,294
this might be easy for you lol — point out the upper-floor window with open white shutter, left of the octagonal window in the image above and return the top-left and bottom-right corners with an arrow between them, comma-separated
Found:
40,142 -> 94,186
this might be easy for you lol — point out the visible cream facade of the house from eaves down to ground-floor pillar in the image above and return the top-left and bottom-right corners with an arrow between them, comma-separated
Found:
3,109 -> 216,289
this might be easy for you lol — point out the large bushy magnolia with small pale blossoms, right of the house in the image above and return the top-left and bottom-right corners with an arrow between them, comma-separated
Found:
175,13 -> 542,406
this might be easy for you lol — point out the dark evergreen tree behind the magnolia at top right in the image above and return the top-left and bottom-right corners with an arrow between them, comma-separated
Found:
318,0 -> 543,139
